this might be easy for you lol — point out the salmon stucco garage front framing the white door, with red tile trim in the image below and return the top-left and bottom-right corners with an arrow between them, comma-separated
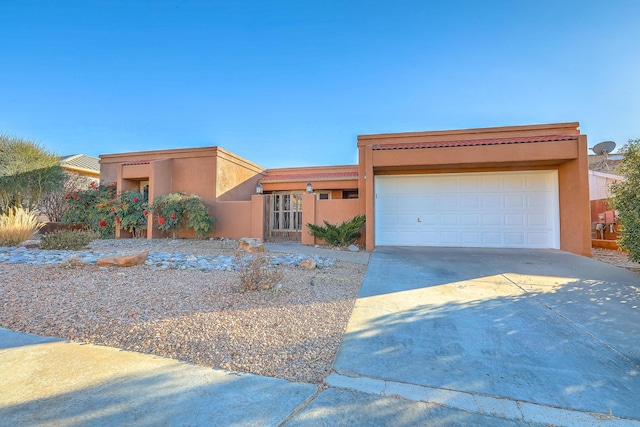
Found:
358,122 -> 591,256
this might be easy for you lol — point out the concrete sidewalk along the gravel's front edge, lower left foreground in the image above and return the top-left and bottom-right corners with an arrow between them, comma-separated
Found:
0,329 -> 544,427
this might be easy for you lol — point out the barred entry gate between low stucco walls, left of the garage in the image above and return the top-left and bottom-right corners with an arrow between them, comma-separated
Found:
263,193 -> 303,242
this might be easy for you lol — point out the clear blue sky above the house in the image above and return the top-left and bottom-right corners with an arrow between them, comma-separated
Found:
0,0 -> 640,168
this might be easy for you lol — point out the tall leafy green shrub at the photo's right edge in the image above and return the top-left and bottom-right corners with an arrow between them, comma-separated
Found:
608,139 -> 640,262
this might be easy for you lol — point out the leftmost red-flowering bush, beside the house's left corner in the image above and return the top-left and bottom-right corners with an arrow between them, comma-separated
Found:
62,182 -> 116,239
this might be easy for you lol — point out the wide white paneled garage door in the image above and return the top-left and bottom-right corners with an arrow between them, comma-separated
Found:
375,171 -> 560,249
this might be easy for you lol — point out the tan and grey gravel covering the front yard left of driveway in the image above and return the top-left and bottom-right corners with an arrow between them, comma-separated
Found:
0,239 -> 366,384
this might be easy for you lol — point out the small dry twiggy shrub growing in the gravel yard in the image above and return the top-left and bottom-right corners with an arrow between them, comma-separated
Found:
236,251 -> 284,291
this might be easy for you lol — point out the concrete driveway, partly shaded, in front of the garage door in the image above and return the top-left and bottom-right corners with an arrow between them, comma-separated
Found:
329,247 -> 640,425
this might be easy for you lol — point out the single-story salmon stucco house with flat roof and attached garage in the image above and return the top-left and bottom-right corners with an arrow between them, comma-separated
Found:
100,122 -> 591,256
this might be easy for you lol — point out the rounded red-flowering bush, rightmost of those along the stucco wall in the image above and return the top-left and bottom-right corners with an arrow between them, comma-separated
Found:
149,193 -> 215,239
